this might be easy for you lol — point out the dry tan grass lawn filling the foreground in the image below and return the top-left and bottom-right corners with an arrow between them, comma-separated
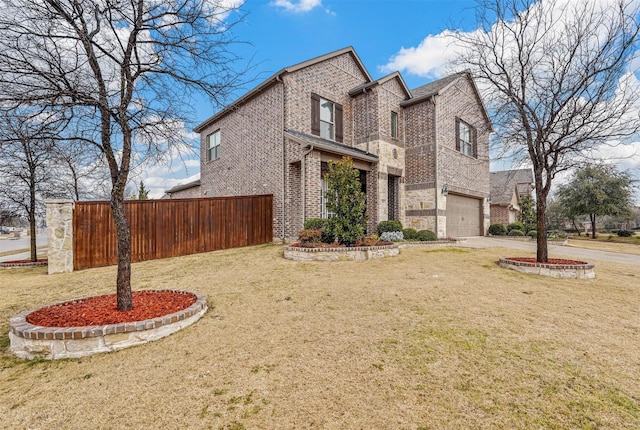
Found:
0,245 -> 640,430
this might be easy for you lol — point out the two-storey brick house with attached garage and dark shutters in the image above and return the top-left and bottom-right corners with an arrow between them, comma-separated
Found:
173,47 -> 491,239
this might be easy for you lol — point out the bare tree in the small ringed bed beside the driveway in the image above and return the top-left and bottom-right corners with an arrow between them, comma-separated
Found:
455,0 -> 640,262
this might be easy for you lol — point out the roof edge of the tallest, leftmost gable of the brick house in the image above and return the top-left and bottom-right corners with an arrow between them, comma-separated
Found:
193,46 -> 372,133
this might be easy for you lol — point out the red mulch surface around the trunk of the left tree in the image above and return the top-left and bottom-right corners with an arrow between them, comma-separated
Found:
26,291 -> 197,327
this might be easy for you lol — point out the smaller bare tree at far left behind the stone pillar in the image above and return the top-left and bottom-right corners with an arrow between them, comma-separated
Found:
0,109 -> 64,261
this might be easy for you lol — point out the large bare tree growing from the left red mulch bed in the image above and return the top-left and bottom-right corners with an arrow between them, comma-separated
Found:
0,0 -> 245,311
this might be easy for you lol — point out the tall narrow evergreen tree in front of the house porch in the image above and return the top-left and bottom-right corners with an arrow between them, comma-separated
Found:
325,157 -> 367,245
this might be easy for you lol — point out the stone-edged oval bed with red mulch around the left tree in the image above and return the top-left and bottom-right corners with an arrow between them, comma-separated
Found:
9,291 -> 207,360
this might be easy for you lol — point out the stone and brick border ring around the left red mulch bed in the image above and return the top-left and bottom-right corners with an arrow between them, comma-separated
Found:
9,291 -> 207,360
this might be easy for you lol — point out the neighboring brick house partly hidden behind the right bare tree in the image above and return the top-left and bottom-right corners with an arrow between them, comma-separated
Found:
491,169 -> 534,224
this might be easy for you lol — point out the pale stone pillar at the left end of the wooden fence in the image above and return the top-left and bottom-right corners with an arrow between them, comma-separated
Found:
45,200 -> 75,275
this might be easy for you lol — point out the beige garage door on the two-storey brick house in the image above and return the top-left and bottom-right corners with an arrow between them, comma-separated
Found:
447,194 -> 483,237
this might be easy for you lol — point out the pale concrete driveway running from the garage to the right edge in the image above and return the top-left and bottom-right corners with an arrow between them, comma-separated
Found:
458,236 -> 640,266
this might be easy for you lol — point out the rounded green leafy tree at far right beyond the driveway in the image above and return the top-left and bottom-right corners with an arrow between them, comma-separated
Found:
558,165 -> 633,239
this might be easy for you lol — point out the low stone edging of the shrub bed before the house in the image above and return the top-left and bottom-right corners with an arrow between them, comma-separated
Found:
284,244 -> 400,261
